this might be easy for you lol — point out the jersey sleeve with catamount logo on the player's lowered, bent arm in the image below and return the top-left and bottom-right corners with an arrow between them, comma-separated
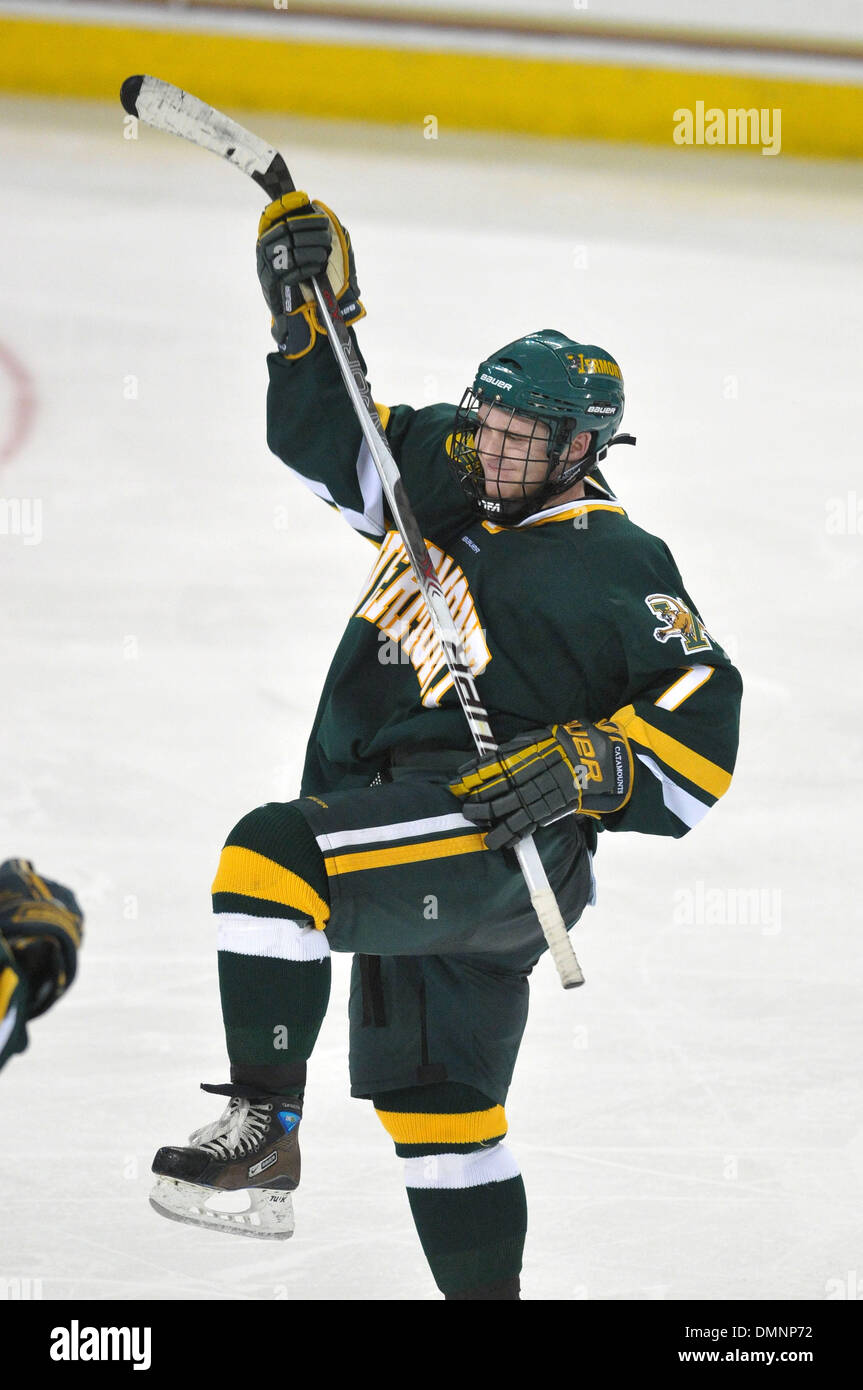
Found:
603,542 -> 742,838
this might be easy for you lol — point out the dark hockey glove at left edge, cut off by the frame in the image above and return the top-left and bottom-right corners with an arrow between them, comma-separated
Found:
0,859 -> 83,1019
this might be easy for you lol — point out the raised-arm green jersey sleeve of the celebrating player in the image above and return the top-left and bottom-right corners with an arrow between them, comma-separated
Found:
267,338 -> 470,545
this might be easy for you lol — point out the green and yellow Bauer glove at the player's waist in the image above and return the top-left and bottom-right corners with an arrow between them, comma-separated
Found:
449,719 -> 632,849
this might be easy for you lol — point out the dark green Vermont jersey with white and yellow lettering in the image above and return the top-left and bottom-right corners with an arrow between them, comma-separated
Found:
267,341 -> 741,838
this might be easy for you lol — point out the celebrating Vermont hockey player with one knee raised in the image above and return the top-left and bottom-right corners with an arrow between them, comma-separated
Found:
151,193 -> 741,1300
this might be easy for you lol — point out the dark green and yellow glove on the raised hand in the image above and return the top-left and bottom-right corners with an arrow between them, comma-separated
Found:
257,190 -> 365,357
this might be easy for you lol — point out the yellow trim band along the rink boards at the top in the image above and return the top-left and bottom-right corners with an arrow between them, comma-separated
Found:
0,13 -> 863,158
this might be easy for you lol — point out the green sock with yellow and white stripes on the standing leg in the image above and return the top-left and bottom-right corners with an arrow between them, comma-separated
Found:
374,1081 -> 527,1300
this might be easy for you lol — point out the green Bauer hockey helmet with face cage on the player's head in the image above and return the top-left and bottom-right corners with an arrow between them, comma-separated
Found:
449,328 -> 635,521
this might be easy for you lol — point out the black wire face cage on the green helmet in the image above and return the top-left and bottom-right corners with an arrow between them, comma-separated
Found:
450,388 -> 595,520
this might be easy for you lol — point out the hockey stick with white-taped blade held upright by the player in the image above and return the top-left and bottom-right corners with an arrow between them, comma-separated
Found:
120,76 -> 584,990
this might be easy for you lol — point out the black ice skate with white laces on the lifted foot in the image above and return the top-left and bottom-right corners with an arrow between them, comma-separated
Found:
150,1095 -> 302,1240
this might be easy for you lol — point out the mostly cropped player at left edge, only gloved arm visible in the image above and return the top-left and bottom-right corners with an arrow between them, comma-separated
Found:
0,859 -> 83,1068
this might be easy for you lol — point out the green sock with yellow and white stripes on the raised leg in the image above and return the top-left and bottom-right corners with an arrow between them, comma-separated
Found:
213,802 -> 331,1099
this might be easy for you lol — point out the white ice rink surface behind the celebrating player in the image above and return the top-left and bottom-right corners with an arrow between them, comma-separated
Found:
0,99 -> 863,1301
